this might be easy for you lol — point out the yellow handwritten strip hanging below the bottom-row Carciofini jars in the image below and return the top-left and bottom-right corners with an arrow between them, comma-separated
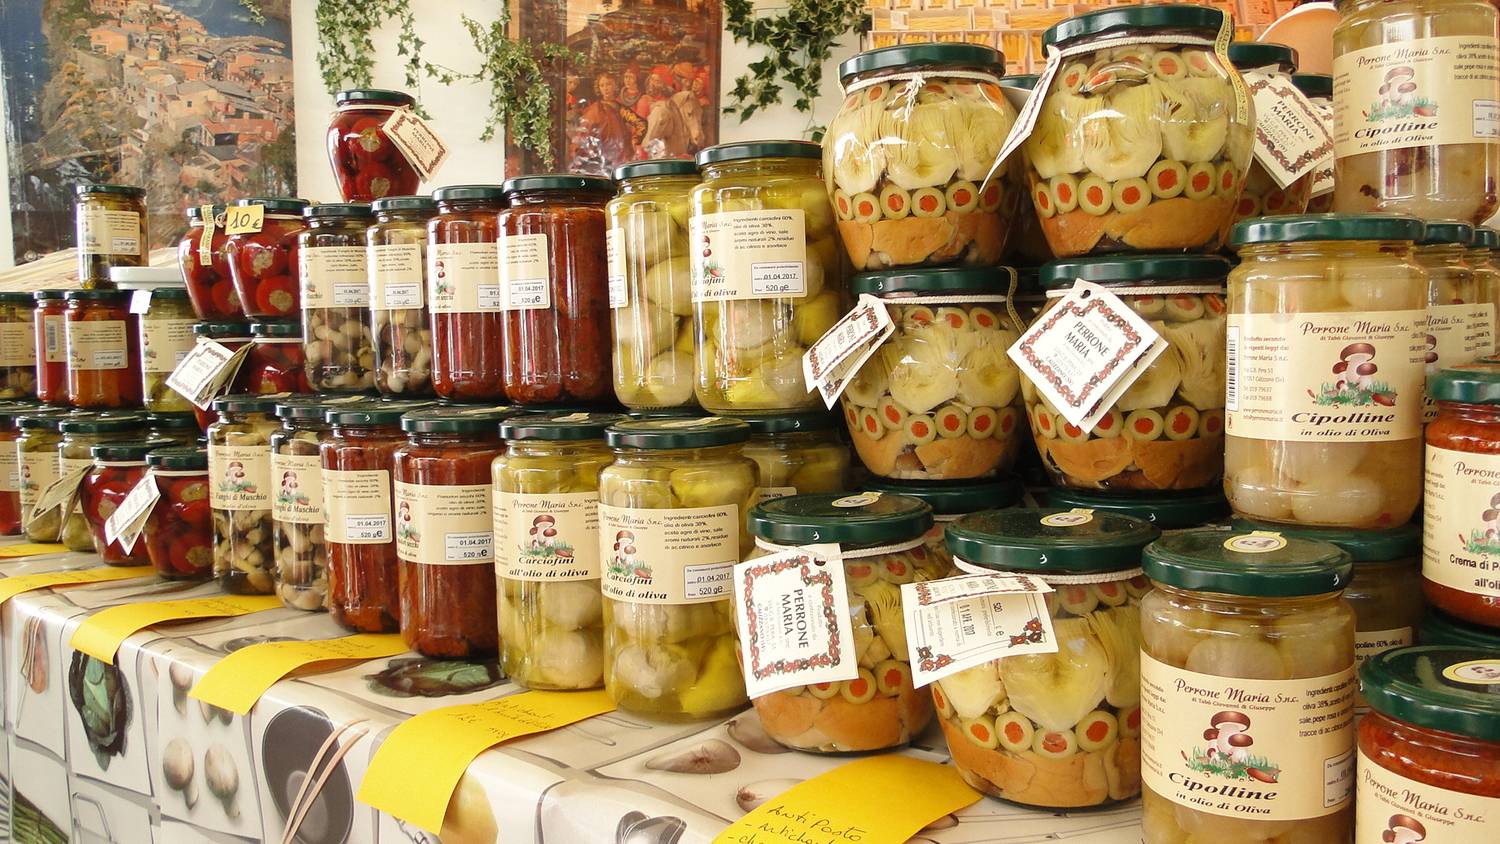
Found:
359,691 -> 615,834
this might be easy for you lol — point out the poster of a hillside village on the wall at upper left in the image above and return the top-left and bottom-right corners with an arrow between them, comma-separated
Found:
0,0 -> 296,261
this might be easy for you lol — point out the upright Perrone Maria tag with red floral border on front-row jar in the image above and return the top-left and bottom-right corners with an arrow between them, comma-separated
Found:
734,544 -> 860,697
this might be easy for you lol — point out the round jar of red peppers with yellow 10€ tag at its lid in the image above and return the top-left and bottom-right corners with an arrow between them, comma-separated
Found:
225,196 -> 308,319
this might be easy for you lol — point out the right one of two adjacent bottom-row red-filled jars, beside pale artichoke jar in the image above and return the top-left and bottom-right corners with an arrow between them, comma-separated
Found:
390,408 -> 507,658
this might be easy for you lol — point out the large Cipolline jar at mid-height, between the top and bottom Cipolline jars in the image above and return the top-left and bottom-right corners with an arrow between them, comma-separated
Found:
1224,214 -> 1427,528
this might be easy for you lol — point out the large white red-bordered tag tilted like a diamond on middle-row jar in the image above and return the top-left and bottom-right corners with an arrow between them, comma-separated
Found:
1007,279 -> 1167,432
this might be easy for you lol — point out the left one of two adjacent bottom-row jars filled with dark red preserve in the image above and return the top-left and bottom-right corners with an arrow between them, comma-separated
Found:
318,402 -> 426,633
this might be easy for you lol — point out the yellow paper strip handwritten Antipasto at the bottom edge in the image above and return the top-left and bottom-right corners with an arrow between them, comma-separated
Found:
714,754 -> 980,844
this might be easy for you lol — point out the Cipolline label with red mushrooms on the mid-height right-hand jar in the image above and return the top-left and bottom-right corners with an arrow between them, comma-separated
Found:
1224,310 -> 1427,442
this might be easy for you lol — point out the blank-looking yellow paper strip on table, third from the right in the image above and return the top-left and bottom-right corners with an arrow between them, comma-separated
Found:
188,633 -> 407,715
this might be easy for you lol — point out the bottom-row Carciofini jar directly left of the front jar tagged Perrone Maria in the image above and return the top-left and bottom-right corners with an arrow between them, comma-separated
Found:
599,418 -> 759,721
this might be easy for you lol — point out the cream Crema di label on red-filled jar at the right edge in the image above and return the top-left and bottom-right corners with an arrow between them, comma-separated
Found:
1422,445 -> 1500,597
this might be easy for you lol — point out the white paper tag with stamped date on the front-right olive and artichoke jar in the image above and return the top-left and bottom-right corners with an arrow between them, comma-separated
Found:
902,574 -> 1058,688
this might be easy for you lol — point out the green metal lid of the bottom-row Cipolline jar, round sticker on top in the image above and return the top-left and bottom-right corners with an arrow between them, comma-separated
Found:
1143,529 -> 1355,598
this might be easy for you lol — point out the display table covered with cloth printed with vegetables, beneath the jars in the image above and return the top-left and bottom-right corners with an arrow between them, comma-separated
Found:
0,543 -> 1140,844
